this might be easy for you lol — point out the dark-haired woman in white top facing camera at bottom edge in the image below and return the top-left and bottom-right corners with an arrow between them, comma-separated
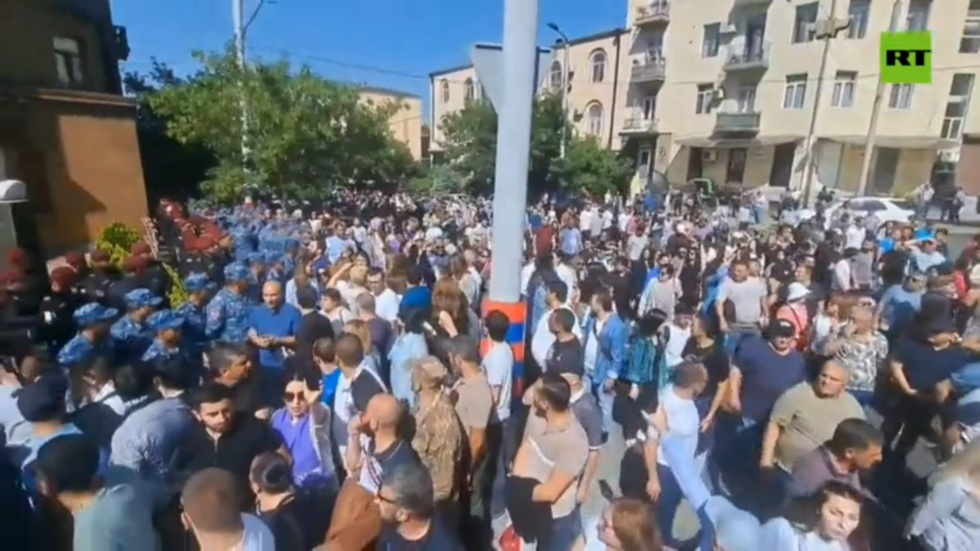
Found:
758,480 -> 869,551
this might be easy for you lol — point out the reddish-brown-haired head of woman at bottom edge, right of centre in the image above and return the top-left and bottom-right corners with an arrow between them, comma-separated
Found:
597,497 -> 666,551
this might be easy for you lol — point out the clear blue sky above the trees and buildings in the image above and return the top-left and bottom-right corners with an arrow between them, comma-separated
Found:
111,0 -> 627,119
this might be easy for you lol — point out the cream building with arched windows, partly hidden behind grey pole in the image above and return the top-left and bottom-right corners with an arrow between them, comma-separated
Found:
429,29 -> 632,156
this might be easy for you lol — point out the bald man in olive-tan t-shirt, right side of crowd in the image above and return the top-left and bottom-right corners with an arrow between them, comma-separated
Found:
760,361 -> 864,472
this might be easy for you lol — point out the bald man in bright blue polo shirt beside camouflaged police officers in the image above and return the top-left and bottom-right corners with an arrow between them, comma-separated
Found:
248,281 -> 303,403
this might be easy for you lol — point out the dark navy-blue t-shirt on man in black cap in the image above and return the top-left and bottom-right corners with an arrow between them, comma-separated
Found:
732,335 -> 806,422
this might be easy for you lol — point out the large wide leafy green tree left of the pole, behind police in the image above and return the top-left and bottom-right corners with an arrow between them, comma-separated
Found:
145,48 -> 412,201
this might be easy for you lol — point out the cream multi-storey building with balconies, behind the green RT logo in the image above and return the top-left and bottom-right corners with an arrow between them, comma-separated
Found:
652,0 -> 980,194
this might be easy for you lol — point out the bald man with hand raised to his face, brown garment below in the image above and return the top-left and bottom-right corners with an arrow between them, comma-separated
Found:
326,394 -> 420,550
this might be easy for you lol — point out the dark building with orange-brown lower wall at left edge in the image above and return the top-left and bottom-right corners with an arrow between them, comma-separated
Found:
0,0 -> 147,254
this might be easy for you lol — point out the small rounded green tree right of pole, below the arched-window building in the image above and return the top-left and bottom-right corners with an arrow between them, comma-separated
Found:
551,136 -> 634,195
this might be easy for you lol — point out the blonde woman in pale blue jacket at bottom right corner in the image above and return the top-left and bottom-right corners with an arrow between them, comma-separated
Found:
905,441 -> 980,551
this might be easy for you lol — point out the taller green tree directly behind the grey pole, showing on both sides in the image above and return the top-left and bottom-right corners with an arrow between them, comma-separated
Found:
440,90 -> 563,193
